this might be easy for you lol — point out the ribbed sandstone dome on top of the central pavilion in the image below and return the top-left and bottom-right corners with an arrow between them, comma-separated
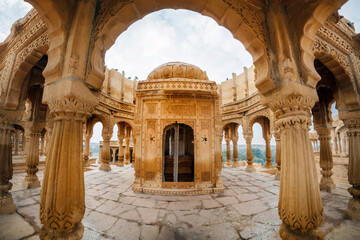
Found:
147,62 -> 209,80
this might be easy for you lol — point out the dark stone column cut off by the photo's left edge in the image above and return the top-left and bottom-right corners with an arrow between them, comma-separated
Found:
0,122 -> 16,214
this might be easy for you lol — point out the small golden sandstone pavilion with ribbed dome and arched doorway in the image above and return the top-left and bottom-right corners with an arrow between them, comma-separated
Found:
133,62 -> 224,194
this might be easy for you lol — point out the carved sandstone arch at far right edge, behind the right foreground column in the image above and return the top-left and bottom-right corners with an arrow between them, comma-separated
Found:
312,39 -> 360,110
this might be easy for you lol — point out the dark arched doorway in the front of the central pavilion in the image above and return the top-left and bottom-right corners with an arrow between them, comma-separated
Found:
162,123 -> 194,182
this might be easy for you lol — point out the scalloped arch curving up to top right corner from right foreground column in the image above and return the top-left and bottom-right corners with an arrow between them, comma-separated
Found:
294,0 -> 346,87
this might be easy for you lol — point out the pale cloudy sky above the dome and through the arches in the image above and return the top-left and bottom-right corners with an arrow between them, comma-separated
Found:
0,0 -> 360,144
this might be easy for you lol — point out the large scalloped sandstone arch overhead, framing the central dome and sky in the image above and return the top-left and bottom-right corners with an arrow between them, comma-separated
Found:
86,0 -> 275,91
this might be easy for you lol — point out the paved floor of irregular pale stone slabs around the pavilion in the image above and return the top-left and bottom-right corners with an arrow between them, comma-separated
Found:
0,165 -> 360,240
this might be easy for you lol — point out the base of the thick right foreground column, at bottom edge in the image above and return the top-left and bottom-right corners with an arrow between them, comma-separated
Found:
279,223 -> 324,240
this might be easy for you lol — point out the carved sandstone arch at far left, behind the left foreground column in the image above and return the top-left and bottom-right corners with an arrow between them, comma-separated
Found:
4,38 -> 49,110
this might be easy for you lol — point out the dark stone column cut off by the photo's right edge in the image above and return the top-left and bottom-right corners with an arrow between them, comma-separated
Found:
339,115 -> 360,220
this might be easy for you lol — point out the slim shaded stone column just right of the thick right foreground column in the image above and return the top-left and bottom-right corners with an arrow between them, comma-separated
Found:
315,127 -> 336,192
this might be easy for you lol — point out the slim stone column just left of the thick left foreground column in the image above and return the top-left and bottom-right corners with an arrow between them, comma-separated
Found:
23,126 -> 41,188
